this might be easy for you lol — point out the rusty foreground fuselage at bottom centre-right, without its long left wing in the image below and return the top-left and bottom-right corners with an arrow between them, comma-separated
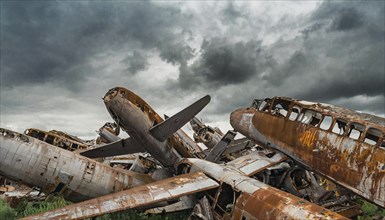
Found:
179,158 -> 346,219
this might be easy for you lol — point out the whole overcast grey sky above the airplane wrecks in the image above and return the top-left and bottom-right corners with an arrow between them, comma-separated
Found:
0,1 -> 385,138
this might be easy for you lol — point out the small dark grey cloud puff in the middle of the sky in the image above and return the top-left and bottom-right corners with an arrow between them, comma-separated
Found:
179,38 -> 271,88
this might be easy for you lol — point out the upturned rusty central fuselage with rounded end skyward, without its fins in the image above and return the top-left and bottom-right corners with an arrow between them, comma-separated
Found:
103,87 -> 199,167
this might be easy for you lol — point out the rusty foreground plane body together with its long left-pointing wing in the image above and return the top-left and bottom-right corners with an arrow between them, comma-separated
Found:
24,158 -> 347,220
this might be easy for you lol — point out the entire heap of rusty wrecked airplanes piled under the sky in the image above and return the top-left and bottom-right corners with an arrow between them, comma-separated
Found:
0,87 -> 385,220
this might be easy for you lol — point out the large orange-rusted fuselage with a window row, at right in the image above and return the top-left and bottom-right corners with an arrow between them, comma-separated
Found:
230,97 -> 385,207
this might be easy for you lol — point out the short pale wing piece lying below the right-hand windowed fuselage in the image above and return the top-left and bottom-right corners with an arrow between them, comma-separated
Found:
227,151 -> 288,176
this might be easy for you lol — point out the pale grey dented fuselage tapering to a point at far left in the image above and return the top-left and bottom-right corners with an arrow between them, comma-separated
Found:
0,128 -> 153,202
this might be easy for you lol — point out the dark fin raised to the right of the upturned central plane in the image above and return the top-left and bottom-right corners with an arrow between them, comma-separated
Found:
150,95 -> 210,141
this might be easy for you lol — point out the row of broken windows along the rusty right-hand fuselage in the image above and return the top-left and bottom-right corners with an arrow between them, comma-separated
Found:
256,100 -> 385,149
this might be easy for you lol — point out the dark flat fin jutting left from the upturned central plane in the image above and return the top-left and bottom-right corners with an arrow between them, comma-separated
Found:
80,138 -> 144,158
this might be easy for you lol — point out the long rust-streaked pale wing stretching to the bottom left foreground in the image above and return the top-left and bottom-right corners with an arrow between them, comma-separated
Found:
25,172 -> 219,219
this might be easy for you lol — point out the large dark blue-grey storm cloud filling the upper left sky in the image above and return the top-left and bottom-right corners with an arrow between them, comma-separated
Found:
1,1 -> 191,88
